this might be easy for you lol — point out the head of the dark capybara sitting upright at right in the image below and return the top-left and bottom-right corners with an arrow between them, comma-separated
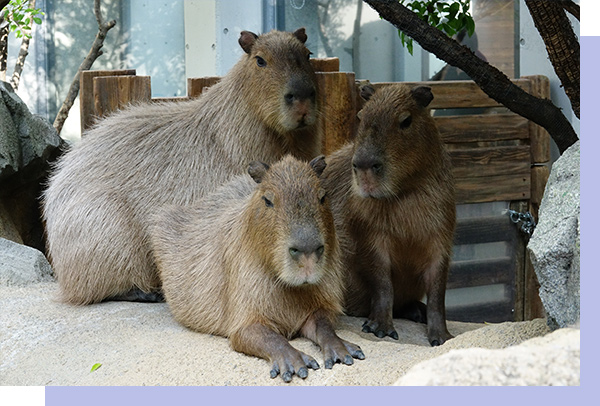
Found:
352,84 -> 440,199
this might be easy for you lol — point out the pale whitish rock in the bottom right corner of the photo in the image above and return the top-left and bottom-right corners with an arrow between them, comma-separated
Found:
396,328 -> 580,386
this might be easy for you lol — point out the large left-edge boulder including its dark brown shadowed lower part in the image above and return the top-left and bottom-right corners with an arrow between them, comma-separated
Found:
0,81 -> 64,249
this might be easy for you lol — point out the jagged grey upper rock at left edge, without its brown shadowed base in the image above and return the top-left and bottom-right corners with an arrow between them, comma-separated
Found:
0,81 -> 64,195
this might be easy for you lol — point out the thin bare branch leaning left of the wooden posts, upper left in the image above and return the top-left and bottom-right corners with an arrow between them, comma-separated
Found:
53,0 -> 117,134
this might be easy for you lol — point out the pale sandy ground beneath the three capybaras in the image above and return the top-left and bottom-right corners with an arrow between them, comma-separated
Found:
0,282 -> 548,386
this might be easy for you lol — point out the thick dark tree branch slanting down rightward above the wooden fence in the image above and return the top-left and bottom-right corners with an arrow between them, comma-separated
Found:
364,0 -> 578,153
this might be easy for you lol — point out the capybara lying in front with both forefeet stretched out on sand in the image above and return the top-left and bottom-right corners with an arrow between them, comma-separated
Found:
150,156 -> 364,382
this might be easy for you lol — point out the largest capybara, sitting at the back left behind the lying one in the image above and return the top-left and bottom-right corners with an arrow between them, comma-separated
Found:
43,28 -> 321,304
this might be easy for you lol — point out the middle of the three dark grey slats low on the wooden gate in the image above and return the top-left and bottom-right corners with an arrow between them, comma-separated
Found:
446,256 -> 515,289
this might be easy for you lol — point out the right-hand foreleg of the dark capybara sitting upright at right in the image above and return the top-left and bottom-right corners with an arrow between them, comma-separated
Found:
426,258 -> 453,347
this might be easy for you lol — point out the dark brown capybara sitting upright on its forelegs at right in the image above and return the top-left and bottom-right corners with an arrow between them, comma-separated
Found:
323,84 -> 456,346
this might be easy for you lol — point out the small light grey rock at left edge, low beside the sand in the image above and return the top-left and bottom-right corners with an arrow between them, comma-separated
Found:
0,238 -> 53,286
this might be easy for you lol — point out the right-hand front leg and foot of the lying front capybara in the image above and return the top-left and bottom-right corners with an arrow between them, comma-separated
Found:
301,310 -> 365,369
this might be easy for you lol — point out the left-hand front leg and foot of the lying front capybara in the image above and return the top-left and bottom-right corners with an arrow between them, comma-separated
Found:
229,323 -> 319,382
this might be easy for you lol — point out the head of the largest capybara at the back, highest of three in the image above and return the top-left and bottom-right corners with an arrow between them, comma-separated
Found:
239,28 -> 317,133
